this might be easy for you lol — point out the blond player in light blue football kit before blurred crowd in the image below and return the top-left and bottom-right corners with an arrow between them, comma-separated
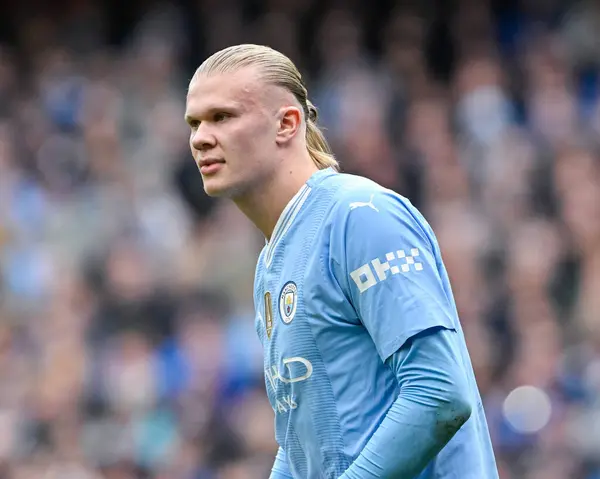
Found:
186,45 -> 498,479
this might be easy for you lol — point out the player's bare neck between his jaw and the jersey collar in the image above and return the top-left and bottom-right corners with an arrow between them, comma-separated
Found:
233,161 -> 318,241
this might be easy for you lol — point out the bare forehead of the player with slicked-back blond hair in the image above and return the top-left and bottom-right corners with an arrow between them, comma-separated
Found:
187,68 -> 267,112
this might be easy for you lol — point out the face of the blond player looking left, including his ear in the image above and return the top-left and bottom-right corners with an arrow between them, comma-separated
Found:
186,68 -> 300,198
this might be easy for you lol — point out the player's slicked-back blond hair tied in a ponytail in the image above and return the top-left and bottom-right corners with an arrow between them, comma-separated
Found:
196,44 -> 339,171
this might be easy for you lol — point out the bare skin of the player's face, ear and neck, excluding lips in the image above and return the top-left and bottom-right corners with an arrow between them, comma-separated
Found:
185,67 -> 318,239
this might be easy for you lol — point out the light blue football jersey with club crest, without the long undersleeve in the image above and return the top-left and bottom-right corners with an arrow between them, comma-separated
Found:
254,169 -> 498,479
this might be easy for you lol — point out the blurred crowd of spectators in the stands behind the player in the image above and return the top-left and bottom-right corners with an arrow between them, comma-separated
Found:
0,0 -> 600,479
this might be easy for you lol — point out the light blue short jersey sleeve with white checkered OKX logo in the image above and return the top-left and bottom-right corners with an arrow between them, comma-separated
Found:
331,190 -> 457,361
